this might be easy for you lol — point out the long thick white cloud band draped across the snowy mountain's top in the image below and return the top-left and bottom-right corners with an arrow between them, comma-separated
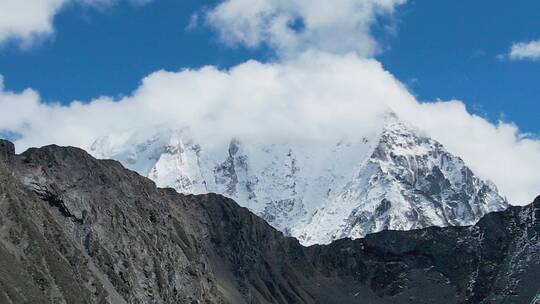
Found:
0,52 -> 540,203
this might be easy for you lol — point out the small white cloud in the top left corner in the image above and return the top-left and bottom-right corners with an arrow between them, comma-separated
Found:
0,0 -> 151,47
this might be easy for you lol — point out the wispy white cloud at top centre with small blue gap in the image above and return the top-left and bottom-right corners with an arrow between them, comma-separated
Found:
206,0 -> 406,56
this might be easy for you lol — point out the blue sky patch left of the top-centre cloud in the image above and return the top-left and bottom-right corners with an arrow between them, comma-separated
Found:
0,0 -> 266,102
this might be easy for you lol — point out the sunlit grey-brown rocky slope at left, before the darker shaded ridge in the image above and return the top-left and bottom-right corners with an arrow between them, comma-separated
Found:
0,141 -> 219,303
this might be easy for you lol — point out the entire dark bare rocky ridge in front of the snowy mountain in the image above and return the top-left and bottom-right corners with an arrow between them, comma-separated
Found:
0,141 -> 540,304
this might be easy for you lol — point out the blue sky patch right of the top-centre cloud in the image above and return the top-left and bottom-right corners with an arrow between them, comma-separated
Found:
379,0 -> 540,133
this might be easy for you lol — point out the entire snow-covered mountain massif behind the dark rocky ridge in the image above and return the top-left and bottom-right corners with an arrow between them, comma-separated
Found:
90,116 -> 508,245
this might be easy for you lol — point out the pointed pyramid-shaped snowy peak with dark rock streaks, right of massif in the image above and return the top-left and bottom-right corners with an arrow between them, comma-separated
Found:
295,120 -> 508,244
